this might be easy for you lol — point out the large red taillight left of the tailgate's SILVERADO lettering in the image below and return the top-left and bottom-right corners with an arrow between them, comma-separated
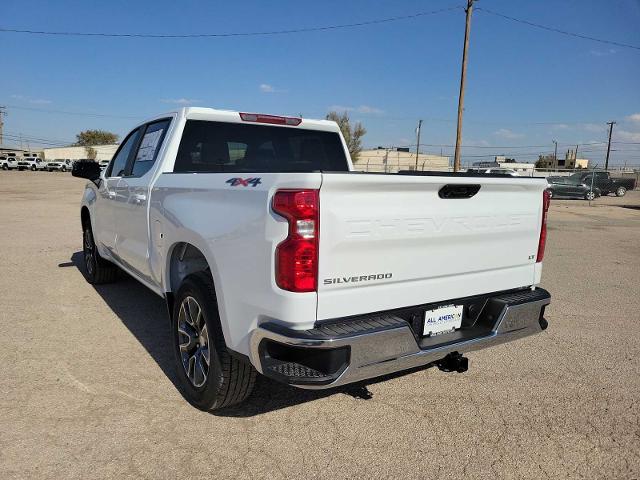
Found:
272,190 -> 320,292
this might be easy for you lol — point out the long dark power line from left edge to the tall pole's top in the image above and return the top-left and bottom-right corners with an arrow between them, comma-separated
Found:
0,5 -> 462,38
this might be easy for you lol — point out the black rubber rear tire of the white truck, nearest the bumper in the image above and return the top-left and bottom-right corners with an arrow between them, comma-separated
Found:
171,272 -> 256,411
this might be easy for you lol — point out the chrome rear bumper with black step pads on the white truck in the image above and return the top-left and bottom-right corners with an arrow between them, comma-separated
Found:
250,289 -> 551,389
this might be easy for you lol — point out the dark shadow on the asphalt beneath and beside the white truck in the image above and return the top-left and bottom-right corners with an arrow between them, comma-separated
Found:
70,252 -> 438,417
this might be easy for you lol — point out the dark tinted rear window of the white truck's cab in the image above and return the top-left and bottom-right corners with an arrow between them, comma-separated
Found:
173,120 -> 349,173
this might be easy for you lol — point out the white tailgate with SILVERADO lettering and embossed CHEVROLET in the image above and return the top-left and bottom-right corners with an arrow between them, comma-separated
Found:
317,173 -> 546,320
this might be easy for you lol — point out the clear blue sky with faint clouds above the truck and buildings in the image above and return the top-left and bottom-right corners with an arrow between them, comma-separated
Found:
0,0 -> 640,165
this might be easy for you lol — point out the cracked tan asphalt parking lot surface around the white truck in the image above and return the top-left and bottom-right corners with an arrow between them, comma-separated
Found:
0,172 -> 640,479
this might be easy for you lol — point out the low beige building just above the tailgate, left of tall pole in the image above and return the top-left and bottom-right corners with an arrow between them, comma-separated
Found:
353,148 -> 449,173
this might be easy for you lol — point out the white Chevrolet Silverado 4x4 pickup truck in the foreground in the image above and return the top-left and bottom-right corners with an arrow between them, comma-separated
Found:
73,108 -> 550,410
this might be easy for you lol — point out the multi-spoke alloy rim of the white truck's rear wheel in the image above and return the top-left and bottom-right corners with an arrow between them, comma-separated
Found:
177,296 -> 210,388
